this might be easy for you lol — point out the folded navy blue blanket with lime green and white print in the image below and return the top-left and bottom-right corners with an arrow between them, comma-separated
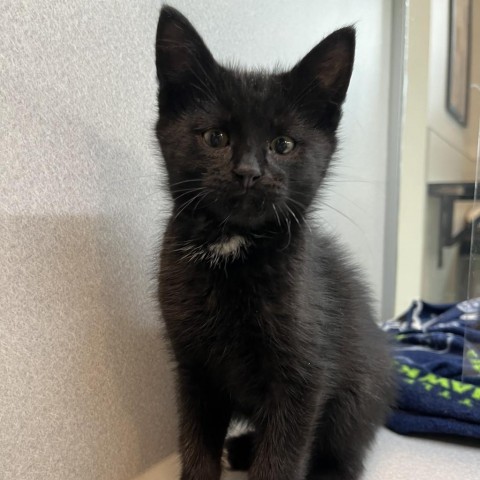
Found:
383,298 -> 480,439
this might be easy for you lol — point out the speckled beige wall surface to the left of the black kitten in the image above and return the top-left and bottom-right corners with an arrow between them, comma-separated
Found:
0,0 -> 175,480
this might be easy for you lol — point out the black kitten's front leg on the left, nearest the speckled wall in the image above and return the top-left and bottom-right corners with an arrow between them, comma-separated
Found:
178,368 -> 231,480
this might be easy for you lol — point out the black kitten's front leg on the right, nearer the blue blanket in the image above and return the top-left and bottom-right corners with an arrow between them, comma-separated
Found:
248,389 -> 318,480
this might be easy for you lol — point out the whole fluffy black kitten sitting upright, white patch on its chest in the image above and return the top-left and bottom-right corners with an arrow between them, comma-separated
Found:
156,7 -> 391,480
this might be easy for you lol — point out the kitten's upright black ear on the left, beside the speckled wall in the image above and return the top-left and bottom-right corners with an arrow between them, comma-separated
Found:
156,6 -> 215,86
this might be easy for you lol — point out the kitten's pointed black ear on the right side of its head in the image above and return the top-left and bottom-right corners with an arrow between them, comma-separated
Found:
292,27 -> 355,104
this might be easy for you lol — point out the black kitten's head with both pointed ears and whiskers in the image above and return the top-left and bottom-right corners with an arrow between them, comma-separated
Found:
156,7 -> 355,230
